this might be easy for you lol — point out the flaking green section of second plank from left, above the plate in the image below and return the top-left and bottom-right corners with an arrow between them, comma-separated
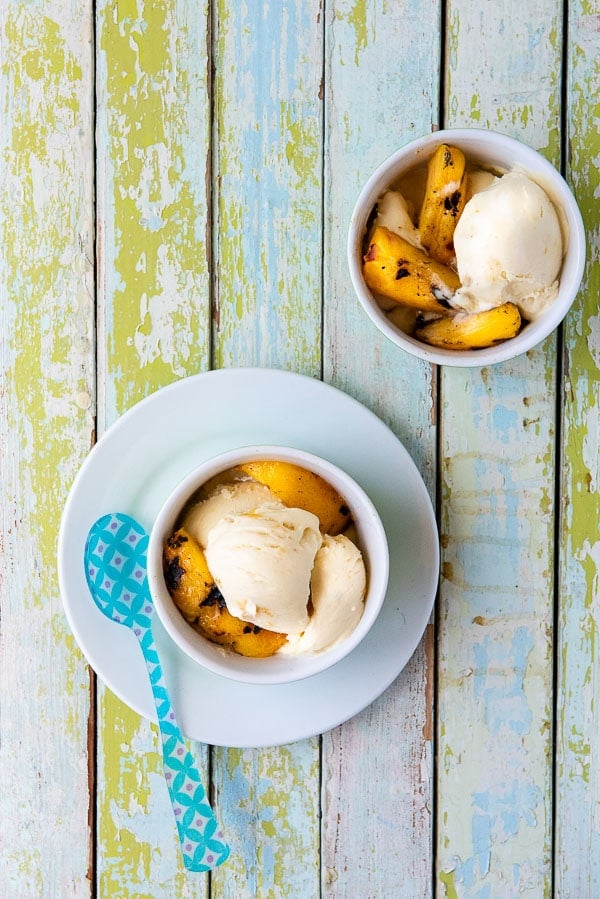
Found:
97,0 -> 210,430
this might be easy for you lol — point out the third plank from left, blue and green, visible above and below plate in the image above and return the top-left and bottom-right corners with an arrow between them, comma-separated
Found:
212,0 -> 323,899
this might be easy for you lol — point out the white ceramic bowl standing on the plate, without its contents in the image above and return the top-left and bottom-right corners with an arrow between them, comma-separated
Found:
148,446 -> 389,684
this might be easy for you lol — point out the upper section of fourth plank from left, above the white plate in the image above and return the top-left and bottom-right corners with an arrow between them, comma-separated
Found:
323,0 -> 440,486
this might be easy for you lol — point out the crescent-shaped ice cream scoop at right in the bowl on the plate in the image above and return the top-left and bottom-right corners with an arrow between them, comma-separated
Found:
279,534 -> 367,655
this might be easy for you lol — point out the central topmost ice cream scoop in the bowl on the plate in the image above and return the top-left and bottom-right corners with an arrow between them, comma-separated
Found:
204,501 -> 322,636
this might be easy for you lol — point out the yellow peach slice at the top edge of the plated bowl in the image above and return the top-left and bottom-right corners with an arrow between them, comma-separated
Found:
239,459 -> 350,536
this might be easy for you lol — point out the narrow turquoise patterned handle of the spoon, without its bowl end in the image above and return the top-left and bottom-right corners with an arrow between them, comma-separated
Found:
137,627 -> 230,871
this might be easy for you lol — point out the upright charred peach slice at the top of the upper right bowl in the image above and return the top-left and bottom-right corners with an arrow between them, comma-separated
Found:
419,144 -> 467,265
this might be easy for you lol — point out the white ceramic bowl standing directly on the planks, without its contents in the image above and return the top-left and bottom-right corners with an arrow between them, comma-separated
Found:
348,129 -> 585,366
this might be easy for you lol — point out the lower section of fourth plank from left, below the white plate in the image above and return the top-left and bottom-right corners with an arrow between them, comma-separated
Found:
321,625 -> 434,899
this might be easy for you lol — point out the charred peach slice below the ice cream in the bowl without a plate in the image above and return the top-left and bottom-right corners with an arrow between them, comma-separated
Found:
415,303 -> 521,350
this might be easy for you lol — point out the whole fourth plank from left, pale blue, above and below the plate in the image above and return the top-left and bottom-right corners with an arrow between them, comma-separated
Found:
322,0 -> 440,899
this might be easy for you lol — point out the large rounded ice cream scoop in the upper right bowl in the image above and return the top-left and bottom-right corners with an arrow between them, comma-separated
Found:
452,171 -> 562,321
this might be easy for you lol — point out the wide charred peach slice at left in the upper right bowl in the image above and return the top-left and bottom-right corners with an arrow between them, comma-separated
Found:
363,227 -> 460,315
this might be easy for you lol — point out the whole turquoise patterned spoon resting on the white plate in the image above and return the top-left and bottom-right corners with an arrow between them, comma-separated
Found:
85,513 -> 229,871
